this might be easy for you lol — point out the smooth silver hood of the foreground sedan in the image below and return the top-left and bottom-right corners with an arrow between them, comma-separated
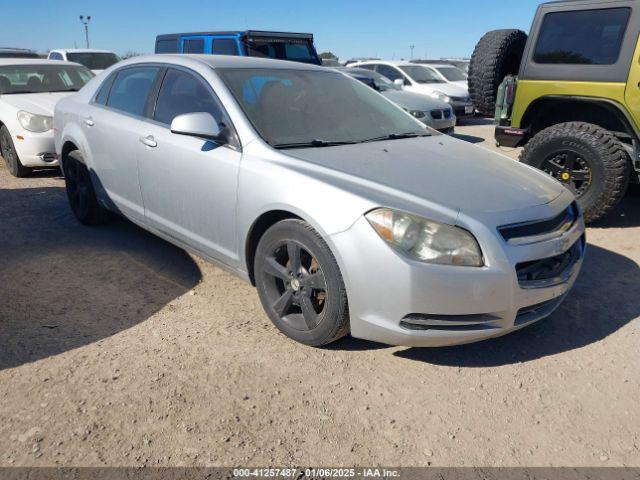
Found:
283,135 -> 564,213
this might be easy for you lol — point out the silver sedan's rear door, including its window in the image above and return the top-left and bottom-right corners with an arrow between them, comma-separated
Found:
81,65 -> 161,219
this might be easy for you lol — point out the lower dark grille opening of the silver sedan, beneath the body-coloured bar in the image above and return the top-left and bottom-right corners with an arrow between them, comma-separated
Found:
516,239 -> 584,288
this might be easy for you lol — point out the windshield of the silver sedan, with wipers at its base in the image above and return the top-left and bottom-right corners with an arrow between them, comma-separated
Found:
216,68 -> 427,148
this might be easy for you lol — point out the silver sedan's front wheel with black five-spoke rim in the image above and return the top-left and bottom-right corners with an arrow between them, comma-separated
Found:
254,219 -> 349,347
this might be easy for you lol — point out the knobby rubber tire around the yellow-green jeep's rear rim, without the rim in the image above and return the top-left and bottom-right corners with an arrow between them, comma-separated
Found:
520,122 -> 631,223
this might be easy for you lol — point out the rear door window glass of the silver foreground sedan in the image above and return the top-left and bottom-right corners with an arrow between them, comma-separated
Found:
107,67 -> 160,116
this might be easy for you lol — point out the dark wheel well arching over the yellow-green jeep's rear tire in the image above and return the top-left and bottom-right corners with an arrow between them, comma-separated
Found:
521,97 -> 637,143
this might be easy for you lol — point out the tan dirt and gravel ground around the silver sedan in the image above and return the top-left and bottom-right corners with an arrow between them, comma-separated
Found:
0,121 -> 640,466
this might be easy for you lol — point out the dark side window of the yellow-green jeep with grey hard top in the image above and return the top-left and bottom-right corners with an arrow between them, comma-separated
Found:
533,8 -> 631,65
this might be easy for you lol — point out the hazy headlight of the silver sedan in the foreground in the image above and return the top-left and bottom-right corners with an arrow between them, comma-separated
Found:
366,208 -> 484,267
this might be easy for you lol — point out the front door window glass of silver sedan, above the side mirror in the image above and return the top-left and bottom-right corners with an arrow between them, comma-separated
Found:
153,68 -> 222,125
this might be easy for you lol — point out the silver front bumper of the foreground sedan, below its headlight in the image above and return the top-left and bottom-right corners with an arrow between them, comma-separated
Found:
331,198 -> 585,347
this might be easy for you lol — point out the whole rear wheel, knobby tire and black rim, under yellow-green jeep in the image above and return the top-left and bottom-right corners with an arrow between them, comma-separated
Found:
520,122 -> 631,223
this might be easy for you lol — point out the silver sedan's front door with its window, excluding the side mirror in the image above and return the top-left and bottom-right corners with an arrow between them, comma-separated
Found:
136,67 -> 241,265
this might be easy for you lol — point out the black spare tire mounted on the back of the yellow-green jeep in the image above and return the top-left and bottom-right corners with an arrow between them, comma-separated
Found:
469,30 -> 527,117
